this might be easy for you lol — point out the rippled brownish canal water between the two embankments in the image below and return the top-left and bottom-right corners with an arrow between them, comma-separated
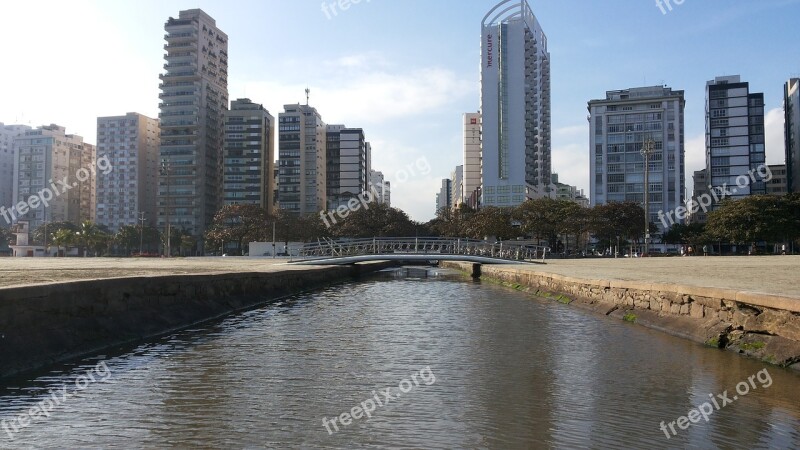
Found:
0,269 -> 800,449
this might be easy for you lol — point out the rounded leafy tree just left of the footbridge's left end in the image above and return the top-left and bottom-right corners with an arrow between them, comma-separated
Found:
205,205 -> 270,255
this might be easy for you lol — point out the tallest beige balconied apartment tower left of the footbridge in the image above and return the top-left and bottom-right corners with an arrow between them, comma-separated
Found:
158,9 -> 228,236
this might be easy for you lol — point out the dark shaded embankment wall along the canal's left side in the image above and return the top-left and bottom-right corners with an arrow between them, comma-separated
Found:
0,263 -> 391,378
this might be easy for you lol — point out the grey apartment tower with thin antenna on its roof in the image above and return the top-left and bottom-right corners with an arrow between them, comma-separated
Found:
278,104 -> 327,214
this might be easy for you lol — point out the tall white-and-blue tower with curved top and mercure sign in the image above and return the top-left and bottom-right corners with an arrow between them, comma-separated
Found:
481,0 -> 551,206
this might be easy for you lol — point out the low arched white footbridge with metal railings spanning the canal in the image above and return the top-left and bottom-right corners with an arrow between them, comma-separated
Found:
293,238 -> 548,265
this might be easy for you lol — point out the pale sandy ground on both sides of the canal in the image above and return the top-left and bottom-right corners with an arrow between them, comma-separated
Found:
0,256 -> 800,298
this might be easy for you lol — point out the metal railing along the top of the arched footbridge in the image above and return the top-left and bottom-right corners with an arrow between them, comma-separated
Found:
299,238 -> 549,261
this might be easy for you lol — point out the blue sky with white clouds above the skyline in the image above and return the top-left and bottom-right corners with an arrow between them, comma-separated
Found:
0,0 -> 800,221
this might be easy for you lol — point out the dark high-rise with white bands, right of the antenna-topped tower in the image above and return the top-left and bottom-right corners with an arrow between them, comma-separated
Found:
325,125 -> 369,211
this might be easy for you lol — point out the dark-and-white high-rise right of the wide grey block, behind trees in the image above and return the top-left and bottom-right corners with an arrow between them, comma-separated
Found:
706,75 -> 767,206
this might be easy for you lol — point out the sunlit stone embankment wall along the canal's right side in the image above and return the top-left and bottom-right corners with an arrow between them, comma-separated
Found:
443,263 -> 800,369
